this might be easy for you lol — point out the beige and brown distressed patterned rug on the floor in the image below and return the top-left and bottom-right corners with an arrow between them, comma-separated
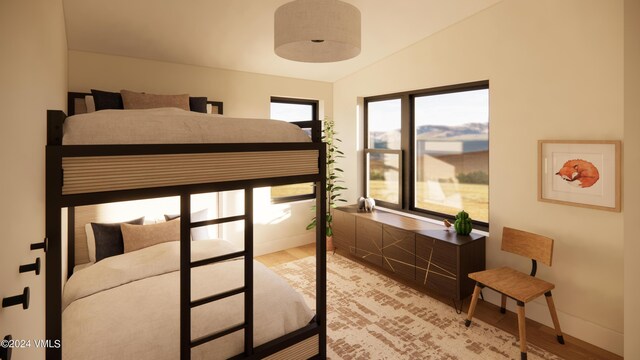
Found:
273,254 -> 561,360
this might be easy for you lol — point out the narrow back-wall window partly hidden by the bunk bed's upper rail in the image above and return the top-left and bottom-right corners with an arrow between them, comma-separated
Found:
271,97 -> 319,203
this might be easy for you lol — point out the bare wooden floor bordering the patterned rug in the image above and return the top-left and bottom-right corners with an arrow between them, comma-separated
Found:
256,244 -> 623,360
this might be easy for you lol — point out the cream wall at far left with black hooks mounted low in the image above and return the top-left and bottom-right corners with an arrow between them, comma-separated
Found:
0,0 -> 67,359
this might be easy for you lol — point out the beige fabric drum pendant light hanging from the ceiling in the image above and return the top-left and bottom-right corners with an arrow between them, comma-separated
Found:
274,0 -> 361,63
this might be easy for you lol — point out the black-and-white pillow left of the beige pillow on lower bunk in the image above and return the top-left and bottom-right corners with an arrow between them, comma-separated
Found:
85,216 -> 144,262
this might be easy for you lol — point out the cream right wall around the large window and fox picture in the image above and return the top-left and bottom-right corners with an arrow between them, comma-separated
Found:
334,0 -> 624,354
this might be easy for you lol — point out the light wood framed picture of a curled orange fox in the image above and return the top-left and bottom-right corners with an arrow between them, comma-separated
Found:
538,140 -> 622,212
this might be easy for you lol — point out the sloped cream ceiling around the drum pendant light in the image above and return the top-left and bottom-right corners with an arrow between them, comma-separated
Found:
64,0 -> 501,82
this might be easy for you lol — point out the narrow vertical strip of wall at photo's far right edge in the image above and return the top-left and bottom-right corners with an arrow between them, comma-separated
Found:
623,0 -> 640,359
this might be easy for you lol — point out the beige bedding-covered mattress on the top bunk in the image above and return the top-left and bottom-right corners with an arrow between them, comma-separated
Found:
62,108 -> 311,145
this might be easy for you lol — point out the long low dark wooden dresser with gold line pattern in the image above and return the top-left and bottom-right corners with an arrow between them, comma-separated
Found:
333,205 -> 486,306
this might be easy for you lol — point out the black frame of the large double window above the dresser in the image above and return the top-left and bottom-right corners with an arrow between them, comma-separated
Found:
362,80 -> 491,230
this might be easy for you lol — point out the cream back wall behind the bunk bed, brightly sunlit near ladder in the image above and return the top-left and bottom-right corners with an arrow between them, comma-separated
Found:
69,51 -> 333,255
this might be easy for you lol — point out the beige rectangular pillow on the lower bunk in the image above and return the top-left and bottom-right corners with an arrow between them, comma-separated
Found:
120,219 -> 180,253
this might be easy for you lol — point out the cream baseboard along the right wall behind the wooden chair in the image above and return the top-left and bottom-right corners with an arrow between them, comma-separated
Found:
483,290 -> 624,356
